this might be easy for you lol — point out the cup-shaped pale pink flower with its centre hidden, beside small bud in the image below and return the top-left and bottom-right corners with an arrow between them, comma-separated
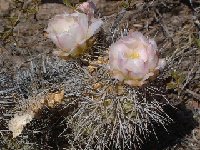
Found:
46,12 -> 103,58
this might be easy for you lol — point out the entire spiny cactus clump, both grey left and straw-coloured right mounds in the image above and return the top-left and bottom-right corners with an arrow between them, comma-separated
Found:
1,34 -> 172,149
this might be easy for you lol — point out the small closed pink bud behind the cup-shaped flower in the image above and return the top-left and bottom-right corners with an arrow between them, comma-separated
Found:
77,1 -> 96,18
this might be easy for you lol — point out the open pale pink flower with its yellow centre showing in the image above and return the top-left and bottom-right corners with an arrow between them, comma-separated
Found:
109,32 -> 166,86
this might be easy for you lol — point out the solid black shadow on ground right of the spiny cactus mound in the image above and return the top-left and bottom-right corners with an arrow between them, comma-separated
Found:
142,104 -> 198,150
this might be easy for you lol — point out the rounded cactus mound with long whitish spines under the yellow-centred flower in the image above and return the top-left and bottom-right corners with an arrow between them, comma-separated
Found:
65,63 -> 172,149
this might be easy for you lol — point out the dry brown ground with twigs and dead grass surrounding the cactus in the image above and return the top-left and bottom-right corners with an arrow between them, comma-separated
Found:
0,0 -> 200,150
